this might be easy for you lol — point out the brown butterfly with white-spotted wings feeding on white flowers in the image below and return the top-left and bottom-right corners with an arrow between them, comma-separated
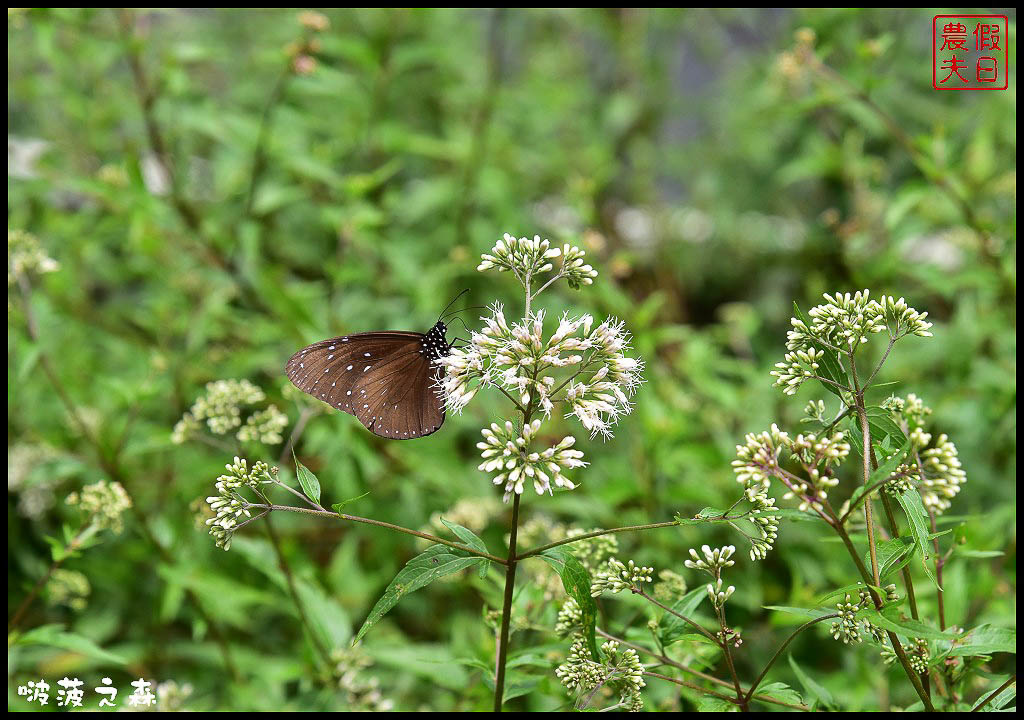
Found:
285,293 -> 462,440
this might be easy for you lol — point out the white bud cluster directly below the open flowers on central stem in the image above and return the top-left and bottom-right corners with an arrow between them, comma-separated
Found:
476,420 -> 587,502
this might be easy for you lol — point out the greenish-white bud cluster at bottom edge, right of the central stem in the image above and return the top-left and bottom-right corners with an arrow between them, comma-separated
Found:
555,638 -> 646,712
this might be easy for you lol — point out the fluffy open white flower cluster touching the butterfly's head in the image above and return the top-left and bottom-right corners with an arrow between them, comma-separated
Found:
438,304 -> 643,437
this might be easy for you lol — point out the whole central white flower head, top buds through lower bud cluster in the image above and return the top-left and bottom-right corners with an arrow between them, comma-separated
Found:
456,234 -> 643,502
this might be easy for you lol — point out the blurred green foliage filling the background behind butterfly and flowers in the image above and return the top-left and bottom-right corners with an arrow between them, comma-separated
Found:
7,9 -> 1016,710
